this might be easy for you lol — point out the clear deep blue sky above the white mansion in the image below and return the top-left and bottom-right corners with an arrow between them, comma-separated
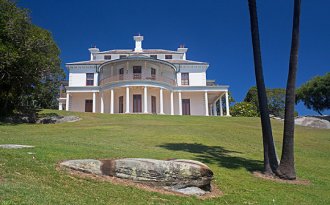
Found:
18,0 -> 330,114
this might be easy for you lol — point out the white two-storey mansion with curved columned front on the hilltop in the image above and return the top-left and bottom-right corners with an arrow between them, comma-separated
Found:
59,36 -> 229,116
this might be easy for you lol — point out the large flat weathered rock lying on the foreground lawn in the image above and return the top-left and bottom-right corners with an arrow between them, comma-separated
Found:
60,158 -> 213,195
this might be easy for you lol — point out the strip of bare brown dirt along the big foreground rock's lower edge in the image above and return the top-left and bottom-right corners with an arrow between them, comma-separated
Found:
56,163 -> 223,199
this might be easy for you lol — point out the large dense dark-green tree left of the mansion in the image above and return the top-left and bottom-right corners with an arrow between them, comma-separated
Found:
0,0 -> 64,115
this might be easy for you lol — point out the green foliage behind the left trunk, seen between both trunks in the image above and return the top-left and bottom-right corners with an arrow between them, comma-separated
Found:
244,86 -> 285,118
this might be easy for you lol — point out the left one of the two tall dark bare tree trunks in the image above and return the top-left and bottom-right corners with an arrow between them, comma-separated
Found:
249,0 -> 278,174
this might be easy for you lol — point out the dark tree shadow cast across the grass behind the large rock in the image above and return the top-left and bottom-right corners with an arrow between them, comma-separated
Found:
159,143 -> 263,172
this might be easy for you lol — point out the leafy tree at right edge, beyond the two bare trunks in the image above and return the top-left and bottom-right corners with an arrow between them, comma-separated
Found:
296,73 -> 330,115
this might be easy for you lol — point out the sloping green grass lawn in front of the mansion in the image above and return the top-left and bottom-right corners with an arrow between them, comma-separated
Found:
0,110 -> 330,204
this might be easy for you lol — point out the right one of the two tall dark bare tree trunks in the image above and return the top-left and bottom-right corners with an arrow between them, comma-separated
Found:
276,0 -> 301,179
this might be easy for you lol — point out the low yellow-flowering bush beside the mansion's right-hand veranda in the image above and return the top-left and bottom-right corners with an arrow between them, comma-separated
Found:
230,102 -> 259,117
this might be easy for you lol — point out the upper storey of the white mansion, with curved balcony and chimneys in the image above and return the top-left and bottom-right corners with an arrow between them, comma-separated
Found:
66,35 -> 209,86
